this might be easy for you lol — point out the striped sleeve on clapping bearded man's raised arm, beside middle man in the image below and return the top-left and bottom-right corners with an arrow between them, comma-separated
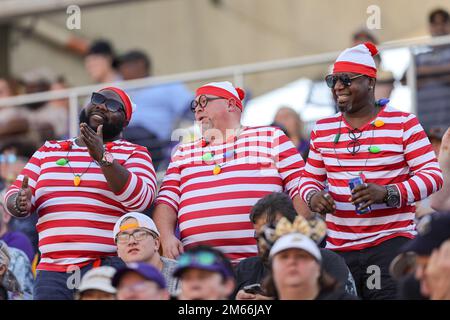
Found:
116,146 -> 156,212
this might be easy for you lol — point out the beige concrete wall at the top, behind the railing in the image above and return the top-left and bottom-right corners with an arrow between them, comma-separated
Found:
7,0 -> 450,93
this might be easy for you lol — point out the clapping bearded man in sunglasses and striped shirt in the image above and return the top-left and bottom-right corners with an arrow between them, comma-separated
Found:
5,87 -> 156,300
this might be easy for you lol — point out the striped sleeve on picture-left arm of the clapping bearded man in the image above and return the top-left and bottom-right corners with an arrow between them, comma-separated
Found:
4,144 -> 47,214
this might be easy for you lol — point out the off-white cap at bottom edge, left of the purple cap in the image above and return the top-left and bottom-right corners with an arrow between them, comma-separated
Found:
78,266 -> 116,294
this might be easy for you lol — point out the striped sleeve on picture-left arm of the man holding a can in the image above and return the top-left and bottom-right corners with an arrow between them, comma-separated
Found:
299,125 -> 327,202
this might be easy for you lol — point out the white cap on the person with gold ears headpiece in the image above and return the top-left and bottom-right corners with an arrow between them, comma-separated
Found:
269,232 -> 322,262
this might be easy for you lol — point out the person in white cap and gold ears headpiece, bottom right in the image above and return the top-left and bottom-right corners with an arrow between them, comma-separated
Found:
264,232 -> 357,300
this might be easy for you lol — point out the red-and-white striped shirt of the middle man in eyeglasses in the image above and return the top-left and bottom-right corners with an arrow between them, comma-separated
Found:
156,127 -> 304,263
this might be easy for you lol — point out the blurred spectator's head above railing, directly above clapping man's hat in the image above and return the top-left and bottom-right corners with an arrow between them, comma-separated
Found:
84,39 -> 122,83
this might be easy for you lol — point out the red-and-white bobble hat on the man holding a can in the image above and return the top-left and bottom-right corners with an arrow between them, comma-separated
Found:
333,42 -> 378,78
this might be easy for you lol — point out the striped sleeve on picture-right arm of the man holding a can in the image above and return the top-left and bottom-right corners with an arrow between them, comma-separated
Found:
396,114 -> 443,205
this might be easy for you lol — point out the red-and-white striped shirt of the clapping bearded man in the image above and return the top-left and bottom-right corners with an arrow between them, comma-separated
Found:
5,140 -> 156,272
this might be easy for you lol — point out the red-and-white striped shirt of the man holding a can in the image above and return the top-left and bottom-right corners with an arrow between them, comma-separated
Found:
299,106 -> 442,251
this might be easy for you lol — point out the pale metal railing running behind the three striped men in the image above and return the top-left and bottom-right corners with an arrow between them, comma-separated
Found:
0,35 -> 450,136
